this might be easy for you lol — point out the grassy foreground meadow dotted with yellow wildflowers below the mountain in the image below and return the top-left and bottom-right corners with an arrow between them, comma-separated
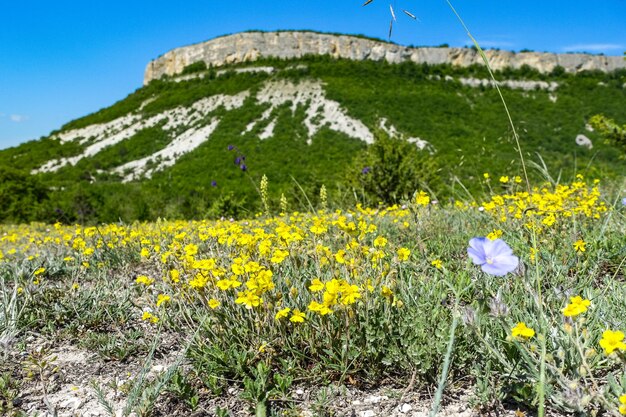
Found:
0,173 -> 626,416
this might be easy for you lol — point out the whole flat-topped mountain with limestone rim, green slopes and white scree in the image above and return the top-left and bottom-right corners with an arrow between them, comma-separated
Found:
0,32 -> 626,222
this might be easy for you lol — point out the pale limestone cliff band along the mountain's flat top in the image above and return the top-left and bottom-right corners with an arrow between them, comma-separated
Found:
144,31 -> 626,84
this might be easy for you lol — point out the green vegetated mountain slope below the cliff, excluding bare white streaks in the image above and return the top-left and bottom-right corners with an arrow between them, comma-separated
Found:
0,56 -> 626,222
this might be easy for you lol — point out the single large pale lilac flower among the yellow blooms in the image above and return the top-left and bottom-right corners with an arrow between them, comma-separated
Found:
467,237 -> 519,277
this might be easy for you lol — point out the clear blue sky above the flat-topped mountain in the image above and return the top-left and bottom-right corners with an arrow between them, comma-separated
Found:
0,0 -> 626,148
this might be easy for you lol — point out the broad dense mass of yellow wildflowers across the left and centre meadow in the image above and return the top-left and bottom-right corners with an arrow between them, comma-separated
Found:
0,203 -> 416,323
